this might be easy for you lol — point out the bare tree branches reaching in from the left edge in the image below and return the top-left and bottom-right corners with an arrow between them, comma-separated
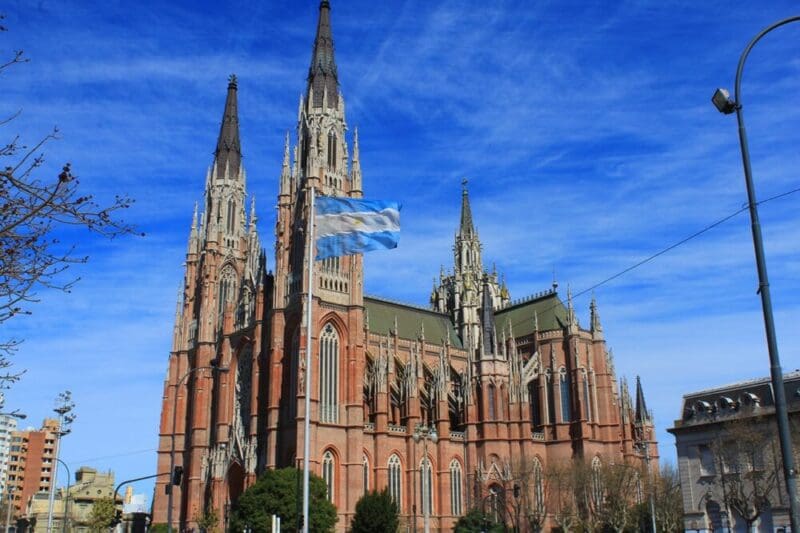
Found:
0,14 -> 133,386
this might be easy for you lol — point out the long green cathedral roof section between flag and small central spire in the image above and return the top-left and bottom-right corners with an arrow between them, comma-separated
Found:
364,296 -> 463,348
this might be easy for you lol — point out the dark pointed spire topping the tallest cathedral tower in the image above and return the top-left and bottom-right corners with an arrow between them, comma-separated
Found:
308,0 -> 339,108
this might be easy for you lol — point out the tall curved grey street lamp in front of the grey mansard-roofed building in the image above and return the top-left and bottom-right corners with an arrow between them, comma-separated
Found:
711,16 -> 800,531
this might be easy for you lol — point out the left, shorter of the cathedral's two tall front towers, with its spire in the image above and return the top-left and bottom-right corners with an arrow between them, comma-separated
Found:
153,76 -> 269,525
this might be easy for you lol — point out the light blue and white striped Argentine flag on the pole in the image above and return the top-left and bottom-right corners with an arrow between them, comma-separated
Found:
315,196 -> 400,261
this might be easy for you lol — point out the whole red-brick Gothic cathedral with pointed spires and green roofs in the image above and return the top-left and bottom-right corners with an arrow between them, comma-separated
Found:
154,0 -> 657,531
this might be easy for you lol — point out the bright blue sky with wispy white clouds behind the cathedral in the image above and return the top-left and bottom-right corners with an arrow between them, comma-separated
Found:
0,0 -> 800,497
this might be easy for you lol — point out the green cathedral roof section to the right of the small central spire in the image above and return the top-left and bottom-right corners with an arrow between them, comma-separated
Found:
494,290 -> 567,337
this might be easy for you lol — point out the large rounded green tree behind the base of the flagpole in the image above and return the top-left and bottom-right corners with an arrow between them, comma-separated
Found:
230,467 -> 338,533
